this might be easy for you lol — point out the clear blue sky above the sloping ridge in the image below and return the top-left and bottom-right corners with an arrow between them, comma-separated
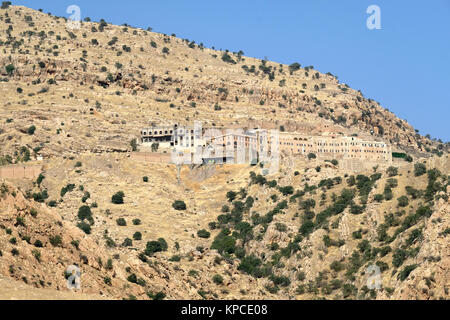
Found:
12,0 -> 450,141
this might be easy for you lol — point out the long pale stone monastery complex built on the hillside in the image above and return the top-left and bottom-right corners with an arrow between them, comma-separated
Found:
140,124 -> 392,163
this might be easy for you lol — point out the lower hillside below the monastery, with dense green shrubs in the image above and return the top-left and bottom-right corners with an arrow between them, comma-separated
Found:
0,151 -> 450,299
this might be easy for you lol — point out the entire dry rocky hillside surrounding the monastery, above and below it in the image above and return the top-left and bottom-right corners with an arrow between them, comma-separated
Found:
0,6 -> 450,299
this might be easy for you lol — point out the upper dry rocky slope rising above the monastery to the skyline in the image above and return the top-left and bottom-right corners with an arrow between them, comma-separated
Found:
0,2 -> 445,162
